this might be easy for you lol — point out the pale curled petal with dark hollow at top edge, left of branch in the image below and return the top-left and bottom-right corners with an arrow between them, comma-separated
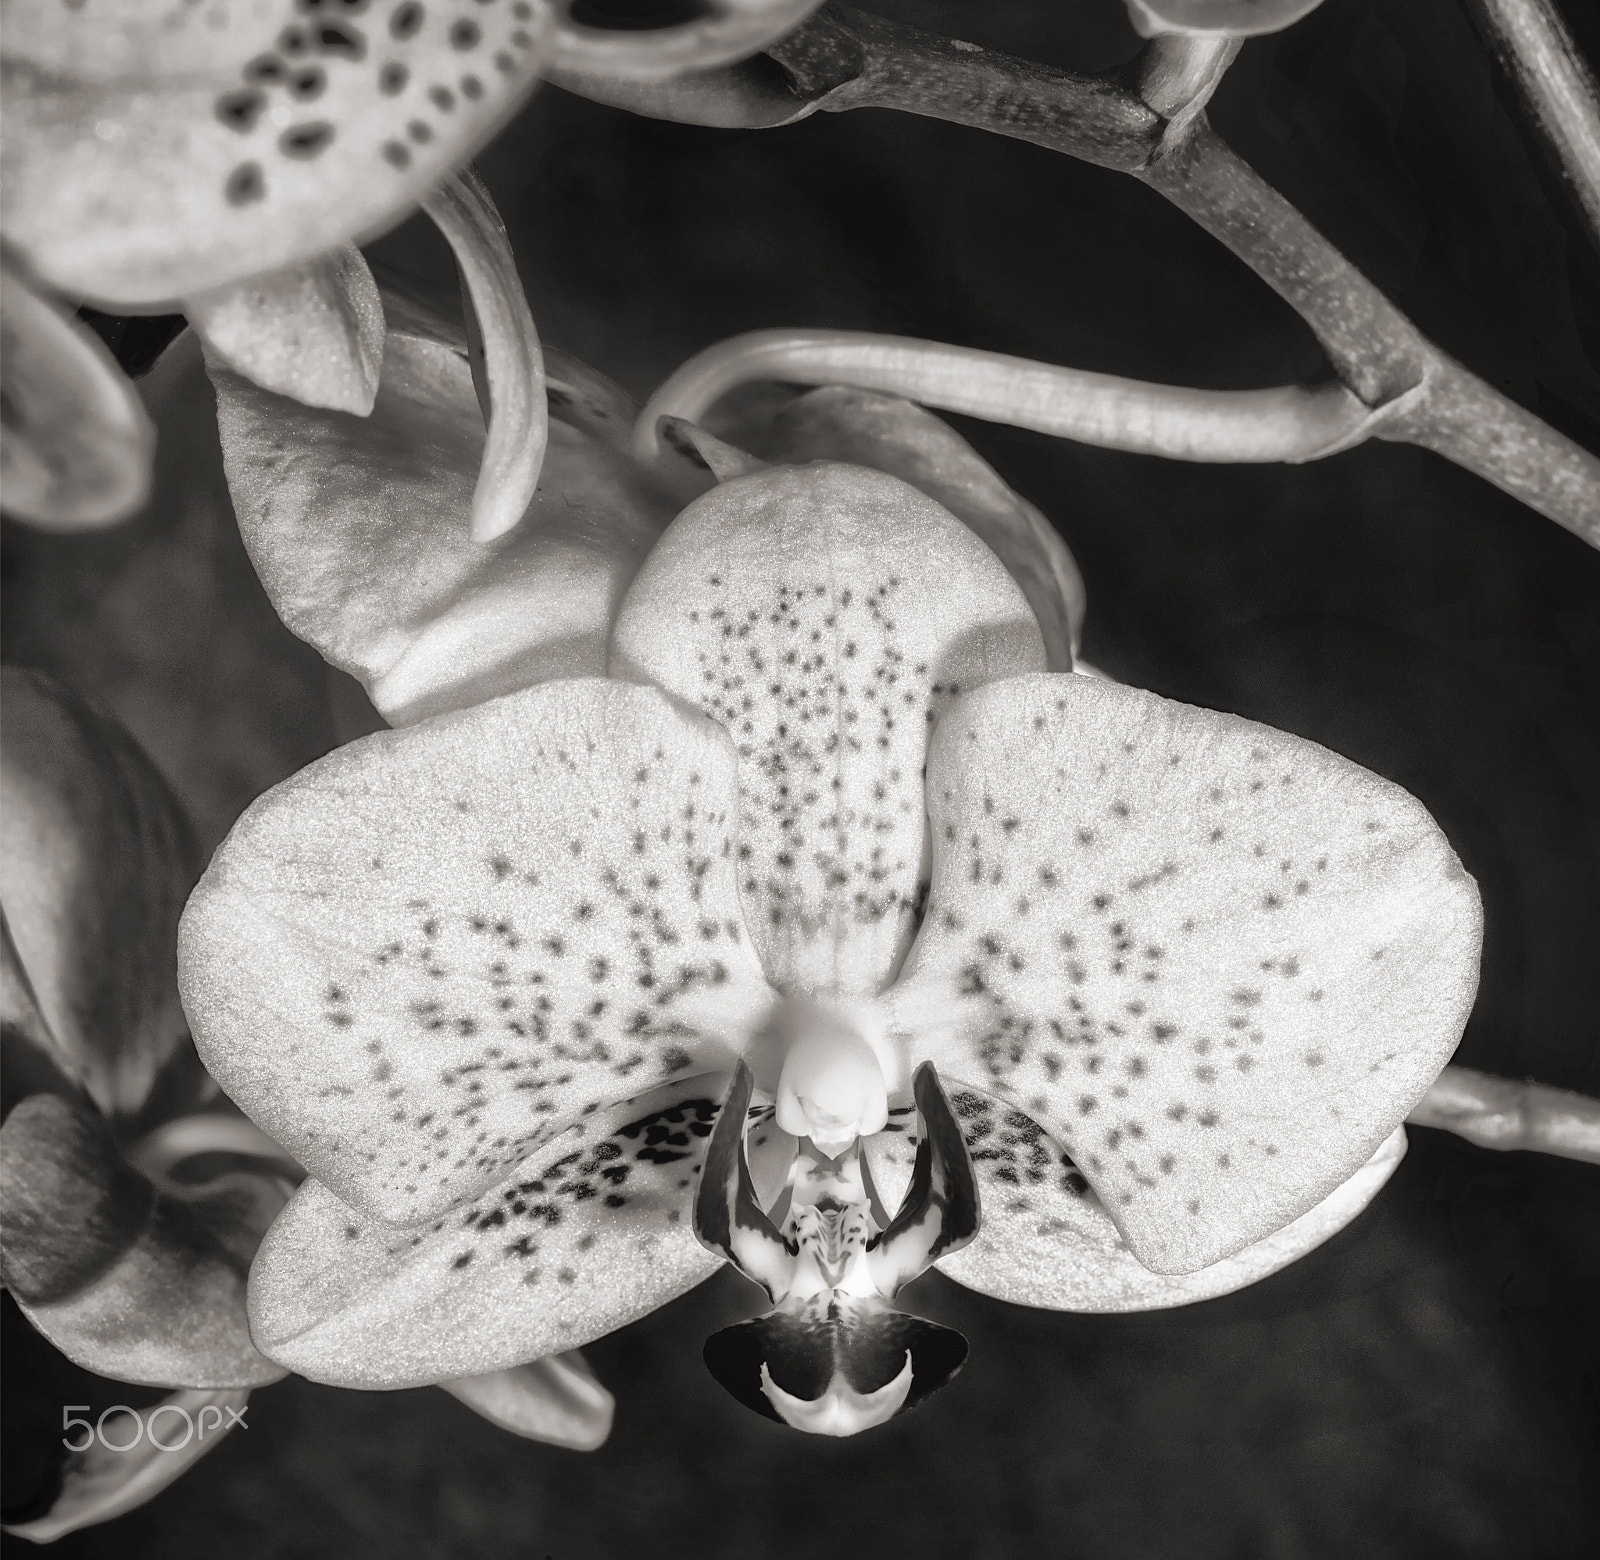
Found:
549,0 -> 822,82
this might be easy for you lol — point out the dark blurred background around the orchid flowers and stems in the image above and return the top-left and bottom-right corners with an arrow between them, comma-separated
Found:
5,0 -> 1600,1560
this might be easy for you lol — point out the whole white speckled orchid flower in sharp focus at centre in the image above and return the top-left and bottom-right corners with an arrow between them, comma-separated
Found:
181,419 -> 1480,1434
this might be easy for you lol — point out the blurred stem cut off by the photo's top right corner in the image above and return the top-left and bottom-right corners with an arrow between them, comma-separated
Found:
1467,0 -> 1600,246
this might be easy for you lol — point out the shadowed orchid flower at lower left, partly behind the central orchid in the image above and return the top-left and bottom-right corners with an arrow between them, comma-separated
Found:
0,667 -> 613,1541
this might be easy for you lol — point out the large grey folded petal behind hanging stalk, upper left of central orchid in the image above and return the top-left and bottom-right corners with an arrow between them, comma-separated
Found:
214,304 -> 672,725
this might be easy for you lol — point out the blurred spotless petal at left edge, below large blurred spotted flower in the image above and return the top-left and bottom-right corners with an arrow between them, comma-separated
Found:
0,266 -> 155,531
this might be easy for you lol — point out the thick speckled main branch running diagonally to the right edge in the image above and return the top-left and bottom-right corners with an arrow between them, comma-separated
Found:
770,5 -> 1600,547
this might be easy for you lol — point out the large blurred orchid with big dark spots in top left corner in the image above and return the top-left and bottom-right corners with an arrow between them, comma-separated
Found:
0,0 -> 818,530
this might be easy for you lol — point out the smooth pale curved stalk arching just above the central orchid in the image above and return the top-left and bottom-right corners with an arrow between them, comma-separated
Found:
635,330 -> 1370,461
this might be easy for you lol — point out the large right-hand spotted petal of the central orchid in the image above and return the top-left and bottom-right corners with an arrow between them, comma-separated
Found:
894,677 -> 1482,1274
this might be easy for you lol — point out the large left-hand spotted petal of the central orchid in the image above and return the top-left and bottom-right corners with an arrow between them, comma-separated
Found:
179,678 -> 770,1228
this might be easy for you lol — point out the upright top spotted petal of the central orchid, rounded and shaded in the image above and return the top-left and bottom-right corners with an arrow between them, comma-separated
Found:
611,462 -> 1043,995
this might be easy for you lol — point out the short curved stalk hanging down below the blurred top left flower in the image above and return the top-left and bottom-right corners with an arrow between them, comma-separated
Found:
422,168 -> 549,542
